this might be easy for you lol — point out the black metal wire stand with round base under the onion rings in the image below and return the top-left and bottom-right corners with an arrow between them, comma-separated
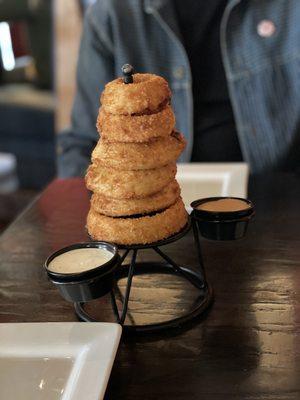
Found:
74,218 -> 213,332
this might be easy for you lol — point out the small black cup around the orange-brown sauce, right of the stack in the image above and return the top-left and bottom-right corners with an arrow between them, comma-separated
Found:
191,197 -> 255,240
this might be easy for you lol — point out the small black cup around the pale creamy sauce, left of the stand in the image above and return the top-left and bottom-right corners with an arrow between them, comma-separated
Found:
45,242 -> 120,302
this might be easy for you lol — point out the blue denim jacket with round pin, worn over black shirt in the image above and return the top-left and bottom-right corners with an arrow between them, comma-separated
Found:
58,0 -> 300,177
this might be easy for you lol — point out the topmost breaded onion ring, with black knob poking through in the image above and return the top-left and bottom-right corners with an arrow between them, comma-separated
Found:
100,74 -> 171,115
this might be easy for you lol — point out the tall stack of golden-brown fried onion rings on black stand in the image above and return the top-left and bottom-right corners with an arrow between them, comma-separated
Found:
86,74 -> 187,245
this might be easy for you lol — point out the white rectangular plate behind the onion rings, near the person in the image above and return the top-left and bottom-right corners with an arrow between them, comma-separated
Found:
176,163 -> 249,211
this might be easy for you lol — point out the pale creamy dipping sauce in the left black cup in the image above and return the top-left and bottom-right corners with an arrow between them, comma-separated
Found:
48,247 -> 114,274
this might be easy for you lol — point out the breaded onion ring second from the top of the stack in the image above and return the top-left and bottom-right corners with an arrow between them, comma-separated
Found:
97,105 -> 175,142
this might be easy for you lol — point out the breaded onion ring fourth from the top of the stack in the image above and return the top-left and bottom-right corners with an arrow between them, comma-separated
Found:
85,163 -> 176,199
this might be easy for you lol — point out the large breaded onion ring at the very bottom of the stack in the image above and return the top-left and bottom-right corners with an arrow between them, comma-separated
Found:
87,198 -> 188,245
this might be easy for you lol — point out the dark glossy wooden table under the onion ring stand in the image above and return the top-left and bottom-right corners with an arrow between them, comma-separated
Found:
0,174 -> 300,400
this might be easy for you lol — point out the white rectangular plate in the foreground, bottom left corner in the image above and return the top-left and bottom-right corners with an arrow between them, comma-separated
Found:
0,322 -> 121,400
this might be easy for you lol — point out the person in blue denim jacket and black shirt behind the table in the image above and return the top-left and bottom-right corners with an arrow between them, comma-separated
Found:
58,0 -> 300,177
